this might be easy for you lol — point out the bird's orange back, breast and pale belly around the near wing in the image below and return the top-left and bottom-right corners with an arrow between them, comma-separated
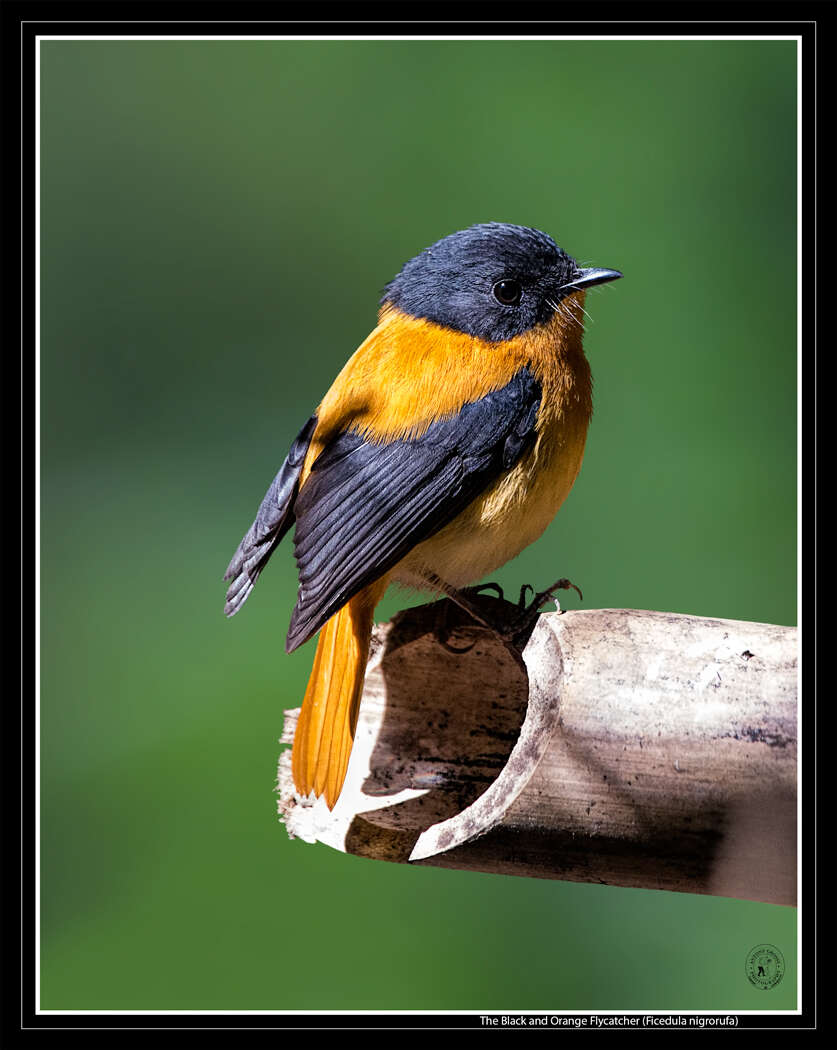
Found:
300,292 -> 592,587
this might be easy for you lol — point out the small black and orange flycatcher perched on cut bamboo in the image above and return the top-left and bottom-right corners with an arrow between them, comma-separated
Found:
224,223 -> 622,810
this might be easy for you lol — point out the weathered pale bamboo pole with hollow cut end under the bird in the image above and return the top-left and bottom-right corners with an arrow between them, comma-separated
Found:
278,596 -> 797,904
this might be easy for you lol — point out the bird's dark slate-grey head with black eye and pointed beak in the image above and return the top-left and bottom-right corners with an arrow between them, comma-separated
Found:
381,223 -> 622,342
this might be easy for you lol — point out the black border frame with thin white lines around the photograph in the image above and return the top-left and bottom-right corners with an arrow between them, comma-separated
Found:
9,0 -> 835,1046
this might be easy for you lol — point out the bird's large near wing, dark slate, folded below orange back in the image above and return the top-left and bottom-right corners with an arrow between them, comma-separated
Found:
286,369 -> 541,652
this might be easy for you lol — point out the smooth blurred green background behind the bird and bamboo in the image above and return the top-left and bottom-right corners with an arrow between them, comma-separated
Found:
41,41 -> 797,1010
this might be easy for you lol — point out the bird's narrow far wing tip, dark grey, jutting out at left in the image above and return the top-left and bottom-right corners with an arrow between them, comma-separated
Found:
224,416 -> 317,616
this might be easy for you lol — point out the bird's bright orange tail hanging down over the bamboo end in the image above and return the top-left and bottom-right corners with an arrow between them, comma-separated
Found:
292,580 -> 386,810
